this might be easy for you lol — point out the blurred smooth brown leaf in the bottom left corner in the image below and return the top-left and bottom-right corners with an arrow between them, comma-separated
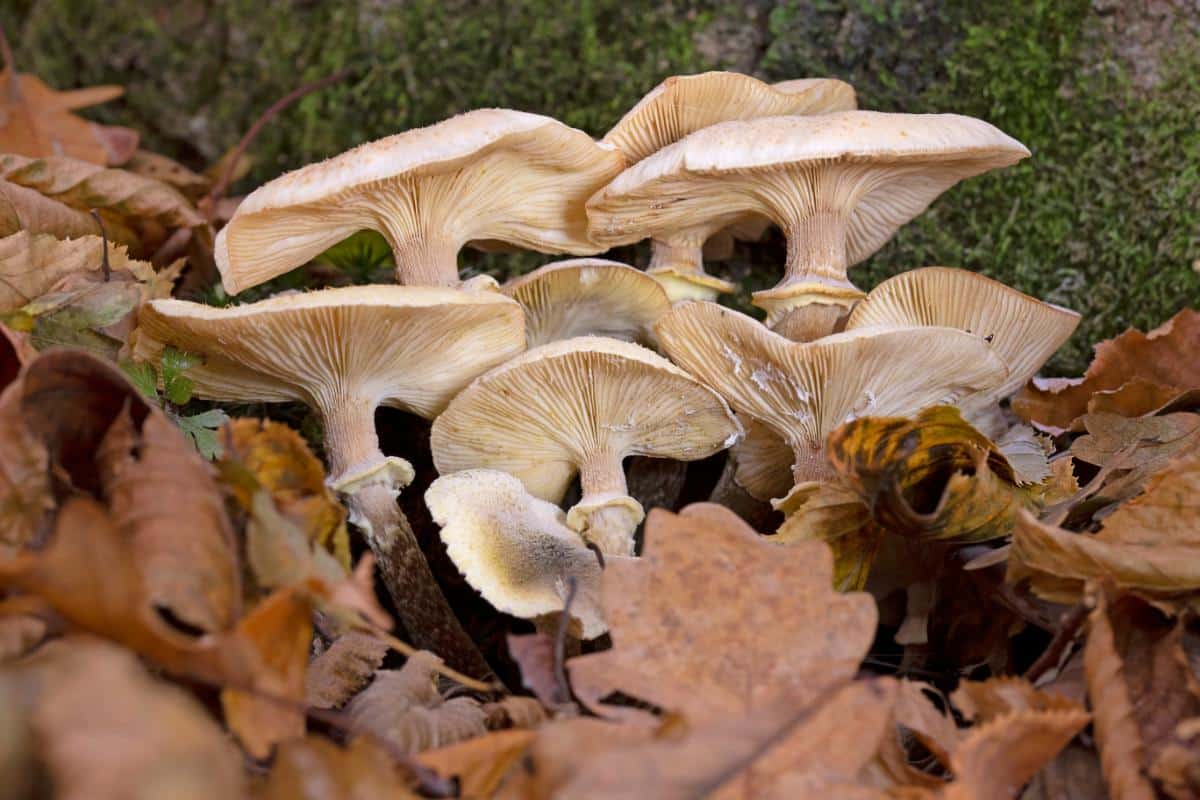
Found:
0,637 -> 246,800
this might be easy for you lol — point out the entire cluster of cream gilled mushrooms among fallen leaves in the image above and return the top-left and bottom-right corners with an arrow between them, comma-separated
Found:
137,72 -> 1078,669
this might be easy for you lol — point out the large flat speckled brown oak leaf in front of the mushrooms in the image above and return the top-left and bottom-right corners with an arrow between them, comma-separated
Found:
568,504 -> 876,722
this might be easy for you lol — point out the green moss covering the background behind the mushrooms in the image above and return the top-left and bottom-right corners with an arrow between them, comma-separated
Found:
11,0 -> 1200,373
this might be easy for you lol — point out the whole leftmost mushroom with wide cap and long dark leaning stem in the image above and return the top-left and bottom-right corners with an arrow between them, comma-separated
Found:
134,285 -> 524,667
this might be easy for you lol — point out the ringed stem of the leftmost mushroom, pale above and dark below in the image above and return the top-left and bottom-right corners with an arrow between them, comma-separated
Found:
322,396 -> 491,676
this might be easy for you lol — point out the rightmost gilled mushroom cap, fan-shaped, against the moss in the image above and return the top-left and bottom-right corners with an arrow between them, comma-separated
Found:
846,266 -> 1079,407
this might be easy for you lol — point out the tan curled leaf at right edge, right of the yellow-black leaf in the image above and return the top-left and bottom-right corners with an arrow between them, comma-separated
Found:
1008,450 -> 1200,603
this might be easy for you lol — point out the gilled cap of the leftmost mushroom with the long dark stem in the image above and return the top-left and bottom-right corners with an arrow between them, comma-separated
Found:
134,285 -> 524,417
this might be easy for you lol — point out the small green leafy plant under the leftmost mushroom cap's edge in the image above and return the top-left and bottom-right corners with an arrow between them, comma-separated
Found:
120,347 -> 229,459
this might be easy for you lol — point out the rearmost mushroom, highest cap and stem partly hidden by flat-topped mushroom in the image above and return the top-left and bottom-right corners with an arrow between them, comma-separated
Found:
604,72 -> 856,300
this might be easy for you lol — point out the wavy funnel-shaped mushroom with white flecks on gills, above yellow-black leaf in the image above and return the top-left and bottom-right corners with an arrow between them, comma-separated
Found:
655,302 -> 1008,512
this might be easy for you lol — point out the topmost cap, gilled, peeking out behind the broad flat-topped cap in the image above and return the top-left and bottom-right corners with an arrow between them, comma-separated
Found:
602,72 -> 856,164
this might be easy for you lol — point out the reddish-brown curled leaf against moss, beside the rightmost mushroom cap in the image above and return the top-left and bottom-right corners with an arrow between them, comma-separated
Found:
1013,308 -> 1200,434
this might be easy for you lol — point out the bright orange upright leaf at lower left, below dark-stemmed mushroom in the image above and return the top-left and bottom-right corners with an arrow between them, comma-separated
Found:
221,589 -> 312,758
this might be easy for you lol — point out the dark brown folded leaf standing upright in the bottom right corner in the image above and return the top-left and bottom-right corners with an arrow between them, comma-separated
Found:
1084,587 -> 1200,800
